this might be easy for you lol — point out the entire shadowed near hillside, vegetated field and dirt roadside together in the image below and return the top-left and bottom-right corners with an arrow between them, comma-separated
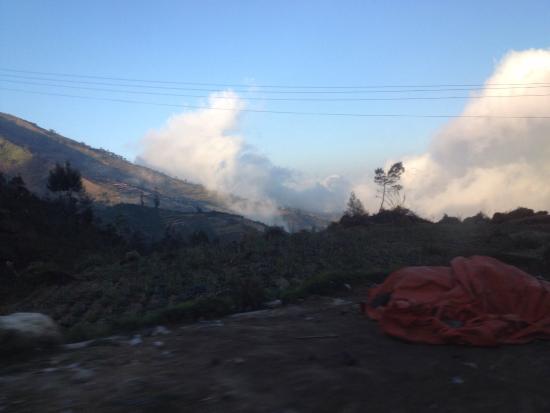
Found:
0,147 -> 550,412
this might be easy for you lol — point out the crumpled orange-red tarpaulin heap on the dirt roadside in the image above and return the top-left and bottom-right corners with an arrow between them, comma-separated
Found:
365,256 -> 550,346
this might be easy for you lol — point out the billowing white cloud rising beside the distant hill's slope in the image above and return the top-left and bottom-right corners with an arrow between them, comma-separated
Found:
139,91 -> 350,221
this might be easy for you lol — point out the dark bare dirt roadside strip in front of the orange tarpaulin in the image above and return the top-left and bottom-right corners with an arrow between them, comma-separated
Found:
0,293 -> 550,413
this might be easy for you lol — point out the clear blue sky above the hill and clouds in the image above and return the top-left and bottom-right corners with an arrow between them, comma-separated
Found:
0,0 -> 550,175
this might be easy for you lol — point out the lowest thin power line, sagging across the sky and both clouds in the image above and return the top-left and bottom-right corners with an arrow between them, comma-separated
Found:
4,87 -> 550,120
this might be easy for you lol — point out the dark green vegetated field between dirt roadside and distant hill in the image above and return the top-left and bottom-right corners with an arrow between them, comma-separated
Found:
0,161 -> 550,340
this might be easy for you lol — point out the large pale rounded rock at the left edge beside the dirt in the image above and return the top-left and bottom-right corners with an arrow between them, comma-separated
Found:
0,313 -> 63,352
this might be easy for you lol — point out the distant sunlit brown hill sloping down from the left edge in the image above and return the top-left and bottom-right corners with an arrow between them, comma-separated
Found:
0,113 -> 330,231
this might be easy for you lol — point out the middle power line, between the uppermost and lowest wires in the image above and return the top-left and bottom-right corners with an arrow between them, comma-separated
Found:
0,78 -> 550,102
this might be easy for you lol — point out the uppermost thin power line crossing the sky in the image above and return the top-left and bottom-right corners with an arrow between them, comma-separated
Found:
0,68 -> 550,93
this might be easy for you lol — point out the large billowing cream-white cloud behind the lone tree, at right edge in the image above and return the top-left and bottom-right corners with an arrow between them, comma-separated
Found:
358,49 -> 550,218
